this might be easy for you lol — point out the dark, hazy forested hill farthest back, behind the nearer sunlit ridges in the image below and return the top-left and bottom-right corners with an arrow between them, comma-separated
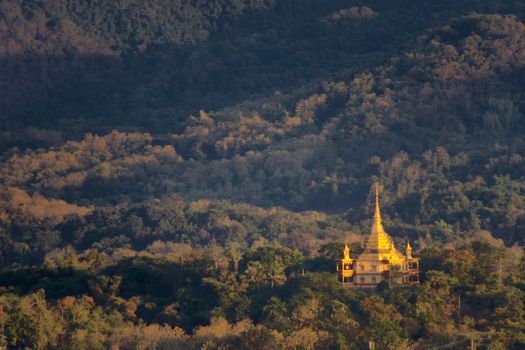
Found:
0,0 -> 522,137
